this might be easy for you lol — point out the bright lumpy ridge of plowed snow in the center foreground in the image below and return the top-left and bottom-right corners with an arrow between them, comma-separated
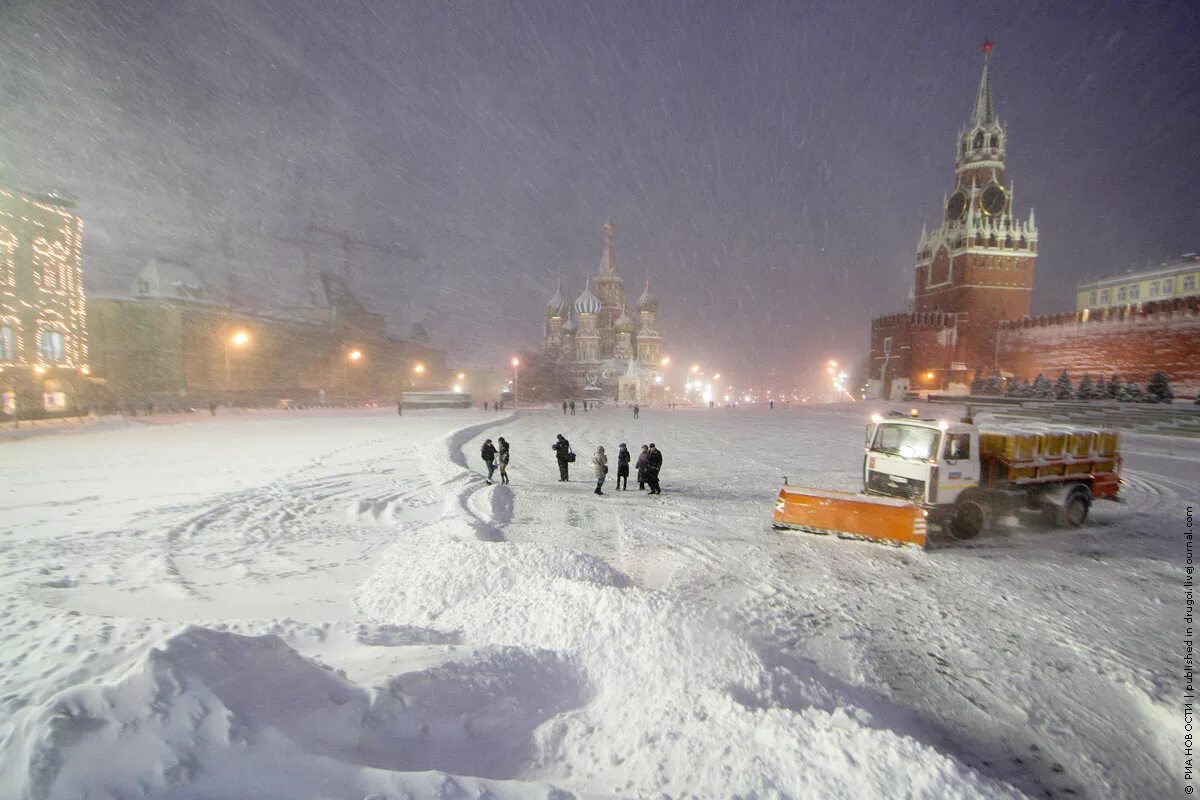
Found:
358,531 -> 1020,799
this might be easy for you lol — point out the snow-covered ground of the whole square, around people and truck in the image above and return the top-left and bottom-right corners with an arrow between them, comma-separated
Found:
0,407 -> 1180,800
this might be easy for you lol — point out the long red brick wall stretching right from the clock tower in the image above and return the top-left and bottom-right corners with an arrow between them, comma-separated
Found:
997,296 -> 1200,396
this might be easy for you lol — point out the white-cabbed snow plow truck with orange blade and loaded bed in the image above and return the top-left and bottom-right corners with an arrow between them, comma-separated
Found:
774,415 -> 1121,547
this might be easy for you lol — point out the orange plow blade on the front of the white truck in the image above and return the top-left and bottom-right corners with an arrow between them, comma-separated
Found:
774,486 -> 925,547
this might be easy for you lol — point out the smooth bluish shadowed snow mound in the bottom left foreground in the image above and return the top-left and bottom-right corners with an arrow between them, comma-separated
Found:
0,627 -> 580,800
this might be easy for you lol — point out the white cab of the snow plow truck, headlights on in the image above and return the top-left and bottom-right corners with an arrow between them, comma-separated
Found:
863,417 -> 979,509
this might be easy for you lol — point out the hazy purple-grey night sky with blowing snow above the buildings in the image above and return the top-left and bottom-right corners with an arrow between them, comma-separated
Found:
0,0 -> 1200,388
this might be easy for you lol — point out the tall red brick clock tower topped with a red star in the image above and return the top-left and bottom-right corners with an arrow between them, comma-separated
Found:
870,42 -> 1038,397
